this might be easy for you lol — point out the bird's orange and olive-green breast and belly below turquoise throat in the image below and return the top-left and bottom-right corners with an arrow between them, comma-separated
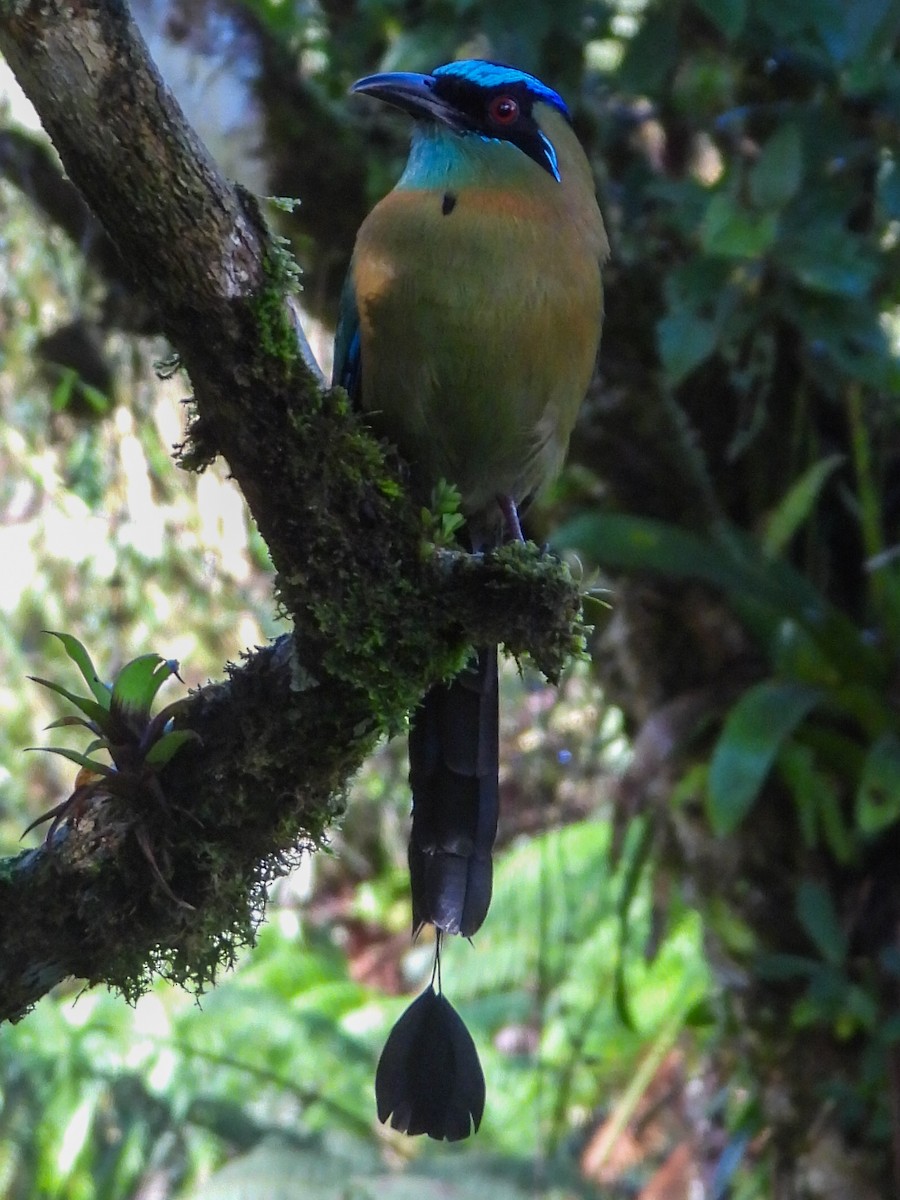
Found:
353,171 -> 602,532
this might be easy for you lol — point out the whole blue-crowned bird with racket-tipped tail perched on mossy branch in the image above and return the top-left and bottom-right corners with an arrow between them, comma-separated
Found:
334,59 -> 608,1140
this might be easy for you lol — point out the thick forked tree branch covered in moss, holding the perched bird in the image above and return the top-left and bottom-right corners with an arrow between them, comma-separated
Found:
0,0 -> 578,1018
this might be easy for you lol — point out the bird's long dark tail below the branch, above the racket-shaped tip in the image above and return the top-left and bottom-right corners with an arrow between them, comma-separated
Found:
409,646 -> 499,937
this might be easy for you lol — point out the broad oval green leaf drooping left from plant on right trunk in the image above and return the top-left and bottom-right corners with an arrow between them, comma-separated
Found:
707,679 -> 822,836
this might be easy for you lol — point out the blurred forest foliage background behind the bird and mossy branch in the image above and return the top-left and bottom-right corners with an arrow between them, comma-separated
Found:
0,0 -> 900,1200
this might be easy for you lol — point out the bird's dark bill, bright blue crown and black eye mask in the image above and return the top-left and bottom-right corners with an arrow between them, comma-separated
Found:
350,59 -> 571,182
